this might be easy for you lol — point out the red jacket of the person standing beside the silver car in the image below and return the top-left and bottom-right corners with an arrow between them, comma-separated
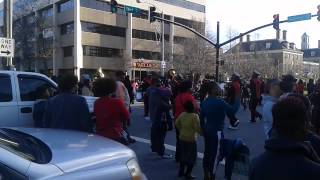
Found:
94,97 -> 129,140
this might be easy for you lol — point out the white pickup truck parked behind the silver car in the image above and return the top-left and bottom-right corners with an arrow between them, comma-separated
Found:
0,71 -> 96,127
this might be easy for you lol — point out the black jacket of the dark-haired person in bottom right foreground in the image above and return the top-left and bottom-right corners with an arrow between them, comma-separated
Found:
249,138 -> 320,180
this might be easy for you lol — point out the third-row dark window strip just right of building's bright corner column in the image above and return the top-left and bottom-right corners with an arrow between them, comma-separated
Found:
83,46 -> 123,57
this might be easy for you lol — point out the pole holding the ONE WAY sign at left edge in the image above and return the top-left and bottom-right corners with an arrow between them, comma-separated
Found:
3,0 -> 13,69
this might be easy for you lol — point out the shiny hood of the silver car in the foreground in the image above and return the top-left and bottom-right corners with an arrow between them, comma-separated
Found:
15,128 -> 136,172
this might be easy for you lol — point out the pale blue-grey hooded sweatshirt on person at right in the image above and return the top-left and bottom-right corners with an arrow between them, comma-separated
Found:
262,95 -> 278,138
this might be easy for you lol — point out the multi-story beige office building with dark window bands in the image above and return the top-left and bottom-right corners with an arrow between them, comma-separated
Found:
0,0 -> 206,77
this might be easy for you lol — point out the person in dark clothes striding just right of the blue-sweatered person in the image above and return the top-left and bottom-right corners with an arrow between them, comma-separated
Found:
226,73 -> 241,130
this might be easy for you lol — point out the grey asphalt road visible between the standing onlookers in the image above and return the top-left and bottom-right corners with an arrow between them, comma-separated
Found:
129,103 -> 265,180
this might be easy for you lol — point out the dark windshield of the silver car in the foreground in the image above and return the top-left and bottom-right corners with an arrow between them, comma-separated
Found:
0,128 -> 52,164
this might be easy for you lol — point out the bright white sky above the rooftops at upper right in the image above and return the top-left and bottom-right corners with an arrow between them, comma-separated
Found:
207,0 -> 320,48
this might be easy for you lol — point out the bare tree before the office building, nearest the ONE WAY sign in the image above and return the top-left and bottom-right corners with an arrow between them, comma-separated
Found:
13,0 -> 53,71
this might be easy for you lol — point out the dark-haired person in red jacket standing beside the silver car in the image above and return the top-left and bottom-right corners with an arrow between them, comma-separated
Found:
94,78 -> 130,145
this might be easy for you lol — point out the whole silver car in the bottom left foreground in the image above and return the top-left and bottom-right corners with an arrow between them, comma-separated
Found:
0,128 -> 146,180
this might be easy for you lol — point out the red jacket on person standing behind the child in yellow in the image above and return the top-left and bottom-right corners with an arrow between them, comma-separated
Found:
174,92 -> 199,120
